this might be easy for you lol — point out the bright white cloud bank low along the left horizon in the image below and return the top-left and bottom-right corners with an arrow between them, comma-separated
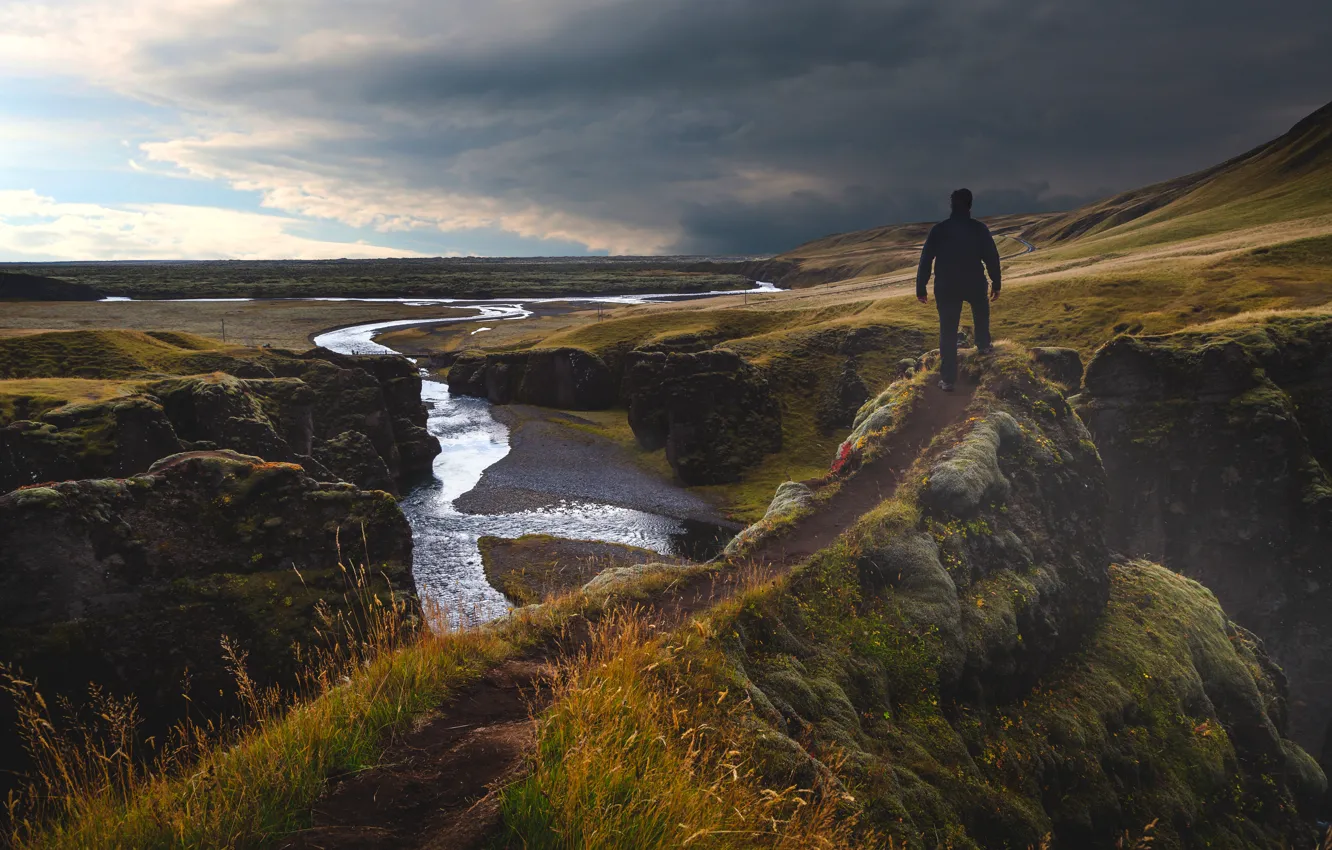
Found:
0,189 -> 425,260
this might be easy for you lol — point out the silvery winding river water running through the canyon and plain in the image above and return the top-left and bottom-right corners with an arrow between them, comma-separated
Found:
305,284 -> 774,622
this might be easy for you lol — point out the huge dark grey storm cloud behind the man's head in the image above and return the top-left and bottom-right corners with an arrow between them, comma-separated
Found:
151,0 -> 1332,253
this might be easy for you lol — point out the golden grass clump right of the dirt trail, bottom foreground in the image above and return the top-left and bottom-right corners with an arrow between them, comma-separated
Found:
502,612 -> 859,850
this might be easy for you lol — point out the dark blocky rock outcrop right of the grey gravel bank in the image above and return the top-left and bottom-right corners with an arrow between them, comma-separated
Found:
625,349 -> 782,485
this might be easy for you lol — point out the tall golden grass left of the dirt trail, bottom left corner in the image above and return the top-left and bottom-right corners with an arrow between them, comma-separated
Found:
7,559 -> 515,850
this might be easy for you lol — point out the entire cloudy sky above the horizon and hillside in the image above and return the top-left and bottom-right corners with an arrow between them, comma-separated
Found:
0,0 -> 1332,261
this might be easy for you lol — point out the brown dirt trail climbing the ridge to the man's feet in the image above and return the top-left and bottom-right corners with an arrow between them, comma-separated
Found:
278,381 -> 975,850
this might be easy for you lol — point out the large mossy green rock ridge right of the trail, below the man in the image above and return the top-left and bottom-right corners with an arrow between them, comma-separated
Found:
714,352 -> 1327,850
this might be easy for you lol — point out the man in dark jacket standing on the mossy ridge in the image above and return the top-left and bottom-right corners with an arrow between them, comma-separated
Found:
916,189 -> 999,393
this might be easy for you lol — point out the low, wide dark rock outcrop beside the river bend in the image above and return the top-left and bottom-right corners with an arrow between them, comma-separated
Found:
449,348 -> 617,410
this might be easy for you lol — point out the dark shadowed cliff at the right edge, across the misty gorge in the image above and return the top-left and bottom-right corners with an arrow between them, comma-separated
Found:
1078,317 -> 1332,788
